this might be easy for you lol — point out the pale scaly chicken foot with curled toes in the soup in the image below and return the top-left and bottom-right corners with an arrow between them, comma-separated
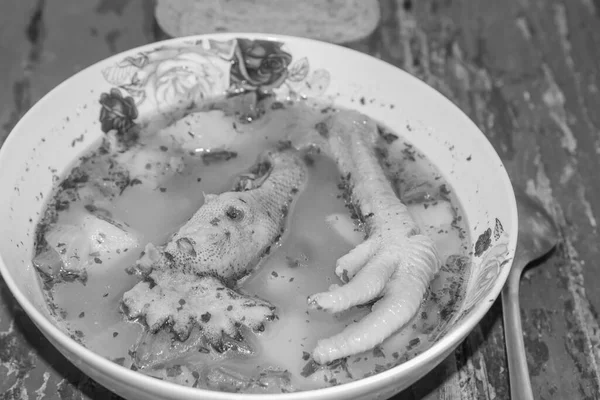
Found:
308,111 -> 441,364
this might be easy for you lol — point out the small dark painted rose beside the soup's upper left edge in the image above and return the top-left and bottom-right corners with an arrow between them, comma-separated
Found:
100,88 -> 138,134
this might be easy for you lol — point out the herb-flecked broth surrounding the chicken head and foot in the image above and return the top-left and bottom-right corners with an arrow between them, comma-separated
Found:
34,98 -> 469,392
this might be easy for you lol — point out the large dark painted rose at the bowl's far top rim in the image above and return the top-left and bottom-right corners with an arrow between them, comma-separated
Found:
230,39 -> 292,90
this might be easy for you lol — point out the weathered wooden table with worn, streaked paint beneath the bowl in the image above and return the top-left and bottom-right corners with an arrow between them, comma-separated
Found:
0,0 -> 600,400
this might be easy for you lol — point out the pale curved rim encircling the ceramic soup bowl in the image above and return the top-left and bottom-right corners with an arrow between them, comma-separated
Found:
0,32 -> 518,400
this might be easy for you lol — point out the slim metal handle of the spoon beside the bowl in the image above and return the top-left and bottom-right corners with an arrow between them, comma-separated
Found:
502,261 -> 534,400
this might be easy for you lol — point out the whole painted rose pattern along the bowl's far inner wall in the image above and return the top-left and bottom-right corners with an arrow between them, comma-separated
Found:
100,38 -> 330,143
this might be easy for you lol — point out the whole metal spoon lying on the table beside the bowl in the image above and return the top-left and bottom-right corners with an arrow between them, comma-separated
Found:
502,187 -> 558,400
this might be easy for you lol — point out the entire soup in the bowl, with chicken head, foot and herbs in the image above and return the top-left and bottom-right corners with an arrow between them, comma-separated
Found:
34,99 -> 469,393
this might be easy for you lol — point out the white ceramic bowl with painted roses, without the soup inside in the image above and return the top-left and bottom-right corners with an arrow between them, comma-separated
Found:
0,34 -> 517,400
